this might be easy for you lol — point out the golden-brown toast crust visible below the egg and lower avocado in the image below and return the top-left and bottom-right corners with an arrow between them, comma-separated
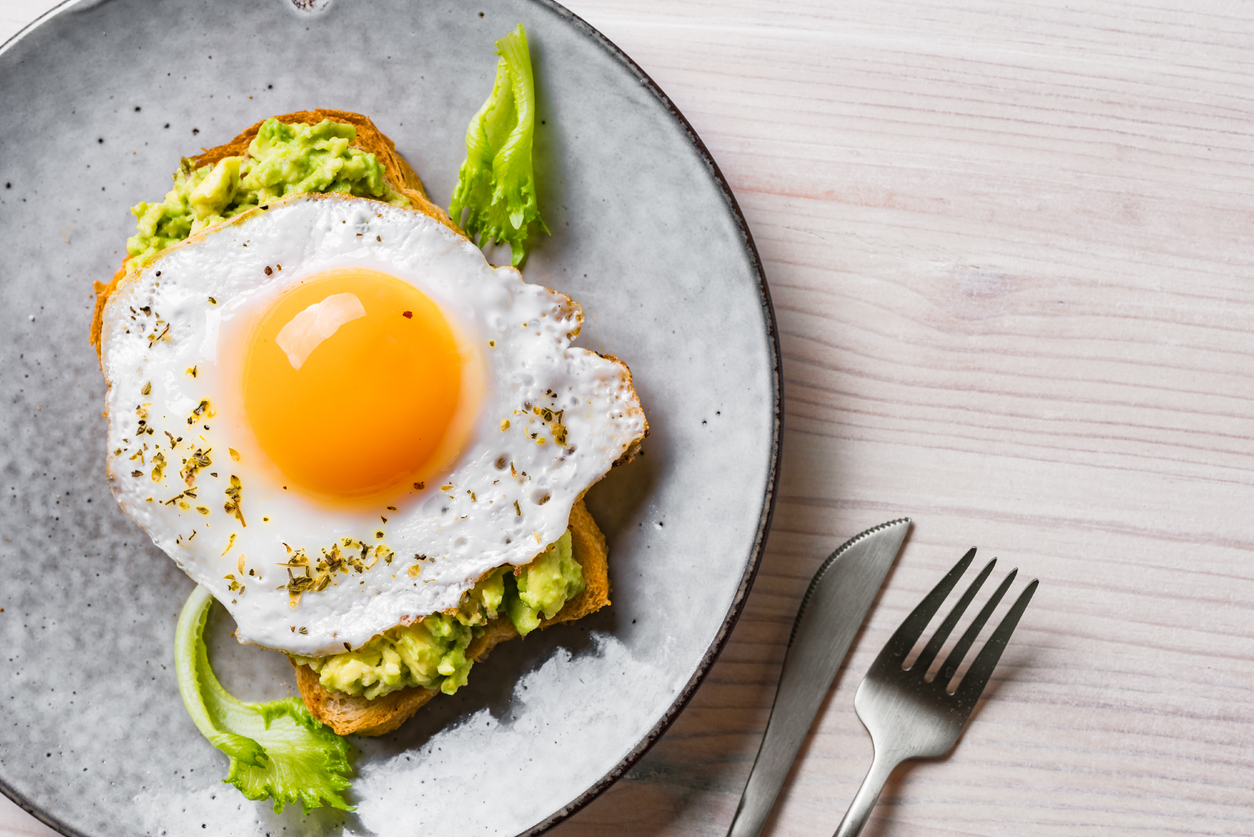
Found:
296,497 -> 609,735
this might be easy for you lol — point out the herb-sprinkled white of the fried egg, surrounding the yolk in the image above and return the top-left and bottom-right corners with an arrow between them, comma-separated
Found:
102,196 -> 647,655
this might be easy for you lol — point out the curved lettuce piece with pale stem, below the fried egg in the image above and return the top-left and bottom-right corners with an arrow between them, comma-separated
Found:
174,586 -> 354,813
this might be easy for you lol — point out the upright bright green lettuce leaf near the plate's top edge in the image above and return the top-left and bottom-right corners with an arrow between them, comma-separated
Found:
449,24 -> 548,267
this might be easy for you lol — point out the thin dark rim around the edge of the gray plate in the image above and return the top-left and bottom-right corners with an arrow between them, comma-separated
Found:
0,0 -> 784,837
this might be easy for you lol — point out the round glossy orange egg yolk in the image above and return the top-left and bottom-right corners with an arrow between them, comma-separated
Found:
243,269 -> 463,497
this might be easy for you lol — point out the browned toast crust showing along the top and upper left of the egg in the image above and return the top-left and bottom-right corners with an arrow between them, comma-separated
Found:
92,110 -> 465,356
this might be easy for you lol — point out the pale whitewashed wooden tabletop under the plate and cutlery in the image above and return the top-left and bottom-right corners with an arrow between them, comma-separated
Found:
0,0 -> 1254,837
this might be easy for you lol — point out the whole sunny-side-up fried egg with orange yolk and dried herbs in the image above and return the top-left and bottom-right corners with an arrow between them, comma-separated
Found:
102,195 -> 647,656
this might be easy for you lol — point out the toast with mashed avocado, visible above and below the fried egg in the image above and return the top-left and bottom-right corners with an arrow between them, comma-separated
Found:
92,110 -> 635,735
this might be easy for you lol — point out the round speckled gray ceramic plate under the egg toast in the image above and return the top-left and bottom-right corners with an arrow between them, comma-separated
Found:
0,0 -> 780,836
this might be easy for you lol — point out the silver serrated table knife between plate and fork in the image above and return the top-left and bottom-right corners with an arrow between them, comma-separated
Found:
727,517 -> 910,837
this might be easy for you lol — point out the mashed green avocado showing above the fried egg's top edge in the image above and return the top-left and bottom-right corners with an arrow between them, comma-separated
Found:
127,119 -> 409,260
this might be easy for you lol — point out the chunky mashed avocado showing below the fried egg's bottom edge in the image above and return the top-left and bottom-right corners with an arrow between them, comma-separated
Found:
295,530 -> 584,699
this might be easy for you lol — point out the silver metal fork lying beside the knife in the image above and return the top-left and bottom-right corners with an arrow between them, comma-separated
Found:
835,548 -> 1037,837
